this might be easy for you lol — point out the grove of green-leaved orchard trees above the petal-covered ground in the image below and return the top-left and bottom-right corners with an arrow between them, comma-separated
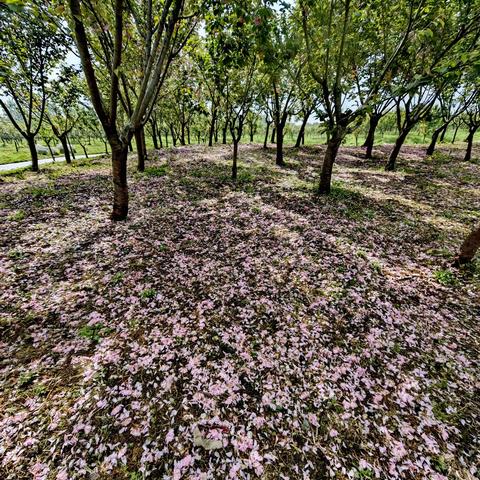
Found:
0,0 -> 480,262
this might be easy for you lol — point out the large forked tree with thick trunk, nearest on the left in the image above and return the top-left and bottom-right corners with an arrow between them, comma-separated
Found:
68,0 -> 197,220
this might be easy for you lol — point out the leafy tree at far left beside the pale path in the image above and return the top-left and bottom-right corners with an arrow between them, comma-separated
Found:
0,2 -> 68,171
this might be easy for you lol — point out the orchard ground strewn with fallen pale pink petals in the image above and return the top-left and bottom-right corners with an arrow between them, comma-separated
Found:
0,146 -> 480,480
